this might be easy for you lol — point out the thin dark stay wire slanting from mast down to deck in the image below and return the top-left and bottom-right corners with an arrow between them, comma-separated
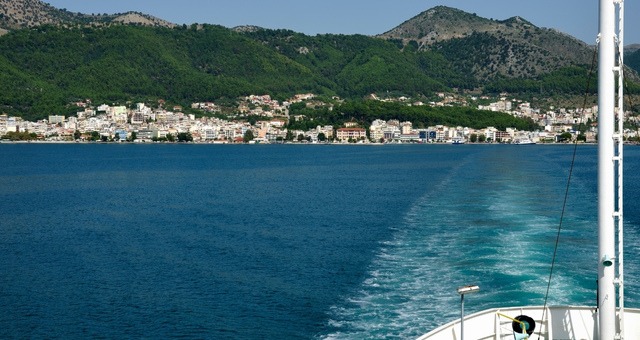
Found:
538,45 -> 598,339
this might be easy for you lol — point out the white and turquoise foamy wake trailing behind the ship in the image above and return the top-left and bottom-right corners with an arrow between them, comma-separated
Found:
326,149 -> 595,339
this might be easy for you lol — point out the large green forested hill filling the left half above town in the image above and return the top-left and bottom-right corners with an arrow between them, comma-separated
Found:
0,26 -> 317,119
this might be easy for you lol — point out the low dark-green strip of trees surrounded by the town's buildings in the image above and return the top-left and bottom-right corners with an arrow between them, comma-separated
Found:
289,100 -> 539,131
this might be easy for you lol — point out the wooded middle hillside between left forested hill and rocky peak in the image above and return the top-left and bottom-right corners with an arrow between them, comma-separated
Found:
241,30 -> 460,97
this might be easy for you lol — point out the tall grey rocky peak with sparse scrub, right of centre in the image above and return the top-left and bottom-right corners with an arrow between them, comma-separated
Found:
379,6 -> 594,80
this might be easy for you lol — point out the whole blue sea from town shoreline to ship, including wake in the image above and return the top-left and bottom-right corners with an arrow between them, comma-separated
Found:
0,143 -> 640,339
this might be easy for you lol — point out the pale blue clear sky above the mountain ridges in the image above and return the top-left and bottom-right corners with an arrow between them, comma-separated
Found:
45,0 -> 640,45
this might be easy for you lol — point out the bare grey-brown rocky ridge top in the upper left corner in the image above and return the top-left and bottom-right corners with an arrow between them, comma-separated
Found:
0,0 -> 175,33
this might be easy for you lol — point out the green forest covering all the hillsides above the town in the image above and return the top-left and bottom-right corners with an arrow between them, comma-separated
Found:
0,25 -> 638,124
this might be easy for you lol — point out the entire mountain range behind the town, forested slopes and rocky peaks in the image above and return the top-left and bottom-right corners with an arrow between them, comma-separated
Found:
0,0 -> 640,119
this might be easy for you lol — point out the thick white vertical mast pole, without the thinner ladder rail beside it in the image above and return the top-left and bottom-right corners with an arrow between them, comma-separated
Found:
598,0 -> 616,340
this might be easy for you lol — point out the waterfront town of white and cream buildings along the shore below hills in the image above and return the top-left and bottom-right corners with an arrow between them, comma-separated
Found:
0,93 -> 638,144
